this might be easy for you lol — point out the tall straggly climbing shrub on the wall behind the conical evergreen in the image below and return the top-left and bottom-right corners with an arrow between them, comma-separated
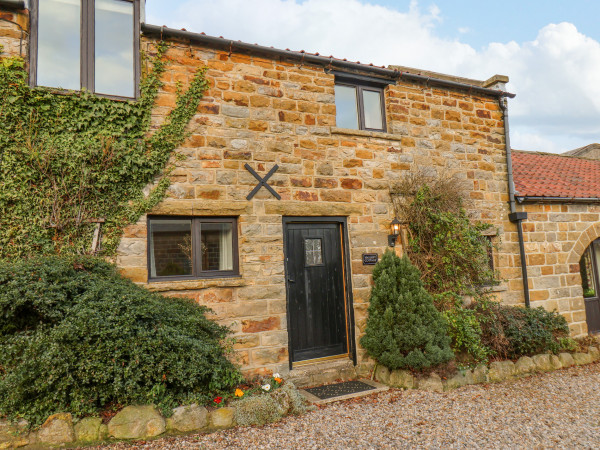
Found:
390,171 -> 497,309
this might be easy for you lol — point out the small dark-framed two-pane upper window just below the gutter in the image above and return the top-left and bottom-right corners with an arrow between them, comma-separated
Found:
335,79 -> 386,131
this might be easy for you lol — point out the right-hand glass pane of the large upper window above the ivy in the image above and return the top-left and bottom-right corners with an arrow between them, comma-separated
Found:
94,0 -> 135,97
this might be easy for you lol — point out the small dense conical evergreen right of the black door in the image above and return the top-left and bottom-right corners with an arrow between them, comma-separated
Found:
360,251 -> 454,370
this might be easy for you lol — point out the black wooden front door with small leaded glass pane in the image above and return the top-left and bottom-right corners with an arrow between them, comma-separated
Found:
284,223 -> 348,362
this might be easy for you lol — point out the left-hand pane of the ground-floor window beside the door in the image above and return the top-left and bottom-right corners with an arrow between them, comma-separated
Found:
150,219 -> 192,277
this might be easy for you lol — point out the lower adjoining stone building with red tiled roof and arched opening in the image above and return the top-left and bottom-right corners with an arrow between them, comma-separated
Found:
509,151 -> 600,335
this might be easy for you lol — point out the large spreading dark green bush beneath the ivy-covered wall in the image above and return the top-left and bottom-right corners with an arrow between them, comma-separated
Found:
0,256 -> 241,424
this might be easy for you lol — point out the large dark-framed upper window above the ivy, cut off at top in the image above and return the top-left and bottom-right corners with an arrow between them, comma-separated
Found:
30,0 -> 140,98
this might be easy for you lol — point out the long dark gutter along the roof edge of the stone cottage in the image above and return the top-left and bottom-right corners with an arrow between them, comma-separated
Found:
142,23 -> 515,98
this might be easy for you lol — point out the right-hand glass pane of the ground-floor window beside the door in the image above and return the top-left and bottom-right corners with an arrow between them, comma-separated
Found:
200,223 -> 233,271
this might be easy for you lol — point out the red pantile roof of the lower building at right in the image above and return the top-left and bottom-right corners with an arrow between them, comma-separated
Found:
512,151 -> 600,198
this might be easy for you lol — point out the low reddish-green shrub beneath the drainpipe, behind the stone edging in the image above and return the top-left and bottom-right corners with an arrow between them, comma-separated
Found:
474,302 -> 572,359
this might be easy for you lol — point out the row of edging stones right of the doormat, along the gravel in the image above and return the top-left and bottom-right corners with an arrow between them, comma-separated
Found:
374,346 -> 600,392
